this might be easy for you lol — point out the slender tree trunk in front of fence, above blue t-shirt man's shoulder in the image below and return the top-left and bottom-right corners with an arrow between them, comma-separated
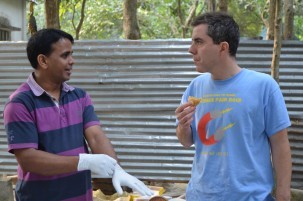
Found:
271,0 -> 283,83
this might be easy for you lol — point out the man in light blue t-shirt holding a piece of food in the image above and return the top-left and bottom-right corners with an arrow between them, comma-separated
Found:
175,12 -> 292,201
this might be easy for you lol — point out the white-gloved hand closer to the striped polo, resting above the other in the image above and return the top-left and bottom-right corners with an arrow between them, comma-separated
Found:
77,154 -> 117,178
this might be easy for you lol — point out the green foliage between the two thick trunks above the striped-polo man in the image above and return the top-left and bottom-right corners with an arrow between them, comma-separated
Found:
60,0 -> 123,39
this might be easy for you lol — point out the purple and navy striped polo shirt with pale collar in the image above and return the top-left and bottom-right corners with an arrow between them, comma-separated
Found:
4,74 -> 100,201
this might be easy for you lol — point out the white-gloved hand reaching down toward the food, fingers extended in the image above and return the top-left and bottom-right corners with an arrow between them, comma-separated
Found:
112,163 -> 153,196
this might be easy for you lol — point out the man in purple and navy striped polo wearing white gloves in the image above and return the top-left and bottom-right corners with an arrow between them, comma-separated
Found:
4,29 -> 152,201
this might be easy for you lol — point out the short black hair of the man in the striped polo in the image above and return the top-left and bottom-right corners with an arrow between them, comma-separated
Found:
26,28 -> 74,69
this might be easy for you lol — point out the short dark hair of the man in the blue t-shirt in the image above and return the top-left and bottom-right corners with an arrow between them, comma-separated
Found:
191,12 -> 240,57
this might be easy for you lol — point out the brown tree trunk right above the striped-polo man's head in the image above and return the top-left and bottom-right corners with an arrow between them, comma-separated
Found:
44,0 -> 61,29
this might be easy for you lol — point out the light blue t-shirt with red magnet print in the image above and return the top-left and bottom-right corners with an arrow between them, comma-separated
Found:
181,69 -> 290,201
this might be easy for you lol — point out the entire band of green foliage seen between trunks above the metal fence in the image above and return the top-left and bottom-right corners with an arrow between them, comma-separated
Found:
30,0 -> 303,40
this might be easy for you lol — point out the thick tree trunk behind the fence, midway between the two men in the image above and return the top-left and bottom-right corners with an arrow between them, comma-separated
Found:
123,0 -> 141,40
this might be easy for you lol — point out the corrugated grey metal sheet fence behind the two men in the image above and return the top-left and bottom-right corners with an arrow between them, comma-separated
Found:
0,40 -> 303,189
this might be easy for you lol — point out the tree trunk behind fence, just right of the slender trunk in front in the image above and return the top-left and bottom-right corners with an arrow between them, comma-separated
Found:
283,0 -> 294,40
